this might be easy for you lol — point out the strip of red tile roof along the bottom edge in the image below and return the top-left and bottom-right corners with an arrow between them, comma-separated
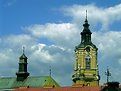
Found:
14,86 -> 101,91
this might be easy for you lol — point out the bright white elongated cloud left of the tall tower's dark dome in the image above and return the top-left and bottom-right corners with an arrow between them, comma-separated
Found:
25,23 -> 73,39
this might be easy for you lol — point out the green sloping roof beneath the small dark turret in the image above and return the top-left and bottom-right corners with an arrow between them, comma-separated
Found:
0,76 -> 59,89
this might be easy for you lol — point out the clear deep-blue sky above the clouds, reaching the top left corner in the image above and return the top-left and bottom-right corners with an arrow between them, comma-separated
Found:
0,0 -> 120,35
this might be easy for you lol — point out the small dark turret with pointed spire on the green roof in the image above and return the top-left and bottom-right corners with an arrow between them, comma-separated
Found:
16,47 -> 29,81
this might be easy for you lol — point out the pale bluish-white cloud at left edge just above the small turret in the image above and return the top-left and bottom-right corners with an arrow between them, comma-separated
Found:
0,34 -> 36,50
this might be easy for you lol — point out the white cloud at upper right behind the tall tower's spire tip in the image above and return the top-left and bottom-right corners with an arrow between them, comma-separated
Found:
62,4 -> 121,30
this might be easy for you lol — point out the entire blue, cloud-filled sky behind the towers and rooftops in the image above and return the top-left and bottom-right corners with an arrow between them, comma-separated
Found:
0,0 -> 121,86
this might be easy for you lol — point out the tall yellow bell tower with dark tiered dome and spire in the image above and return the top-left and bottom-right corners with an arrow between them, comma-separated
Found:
72,11 -> 100,86
